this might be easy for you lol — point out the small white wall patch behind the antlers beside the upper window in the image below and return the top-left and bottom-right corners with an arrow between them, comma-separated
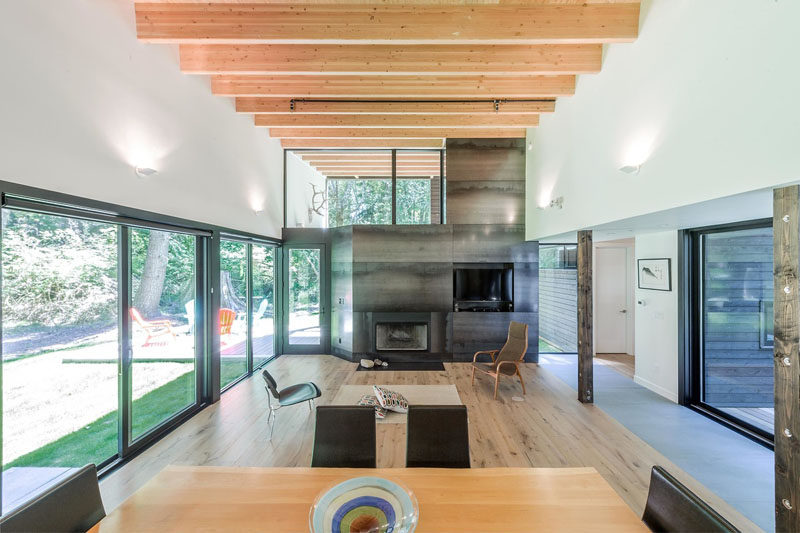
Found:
286,152 -> 328,228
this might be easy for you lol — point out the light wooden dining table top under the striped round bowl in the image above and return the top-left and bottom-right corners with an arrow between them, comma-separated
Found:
90,466 -> 647,533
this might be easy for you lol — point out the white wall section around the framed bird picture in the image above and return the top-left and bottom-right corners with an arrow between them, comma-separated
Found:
634,231 -> 678,402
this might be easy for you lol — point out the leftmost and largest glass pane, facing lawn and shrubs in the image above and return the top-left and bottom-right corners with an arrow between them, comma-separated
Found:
2,209 -> 120,512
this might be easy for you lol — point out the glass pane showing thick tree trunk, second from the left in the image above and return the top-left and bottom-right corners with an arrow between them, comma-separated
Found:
129,229 -> 197,439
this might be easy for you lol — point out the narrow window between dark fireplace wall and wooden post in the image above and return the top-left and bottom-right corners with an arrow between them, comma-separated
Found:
539,244 -> 578,353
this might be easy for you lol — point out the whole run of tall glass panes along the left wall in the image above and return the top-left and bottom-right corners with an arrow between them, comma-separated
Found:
0,189 -> 282,513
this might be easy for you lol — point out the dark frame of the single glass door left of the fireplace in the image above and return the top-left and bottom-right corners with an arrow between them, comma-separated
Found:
280,242 -> 330,354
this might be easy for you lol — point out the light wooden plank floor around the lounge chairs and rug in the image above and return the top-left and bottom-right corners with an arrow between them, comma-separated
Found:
101,355 -> 759,531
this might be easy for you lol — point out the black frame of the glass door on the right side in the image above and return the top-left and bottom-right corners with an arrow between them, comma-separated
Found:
678,218 -> 775,448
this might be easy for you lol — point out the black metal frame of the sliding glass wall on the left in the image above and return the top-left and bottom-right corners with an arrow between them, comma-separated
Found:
0,180 -> 285,514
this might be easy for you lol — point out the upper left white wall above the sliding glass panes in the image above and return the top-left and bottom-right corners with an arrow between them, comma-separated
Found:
0,0 -> 283,237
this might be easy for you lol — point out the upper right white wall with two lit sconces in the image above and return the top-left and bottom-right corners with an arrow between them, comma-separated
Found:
526,0 -> 800,240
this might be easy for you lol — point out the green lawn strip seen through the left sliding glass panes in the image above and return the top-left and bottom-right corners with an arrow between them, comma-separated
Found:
3,372 -> 195,470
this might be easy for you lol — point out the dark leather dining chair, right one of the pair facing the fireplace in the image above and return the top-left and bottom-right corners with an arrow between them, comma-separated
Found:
406,405 -> 469,468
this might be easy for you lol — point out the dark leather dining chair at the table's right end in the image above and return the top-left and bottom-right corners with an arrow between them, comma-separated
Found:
642,465 -> 739,533
